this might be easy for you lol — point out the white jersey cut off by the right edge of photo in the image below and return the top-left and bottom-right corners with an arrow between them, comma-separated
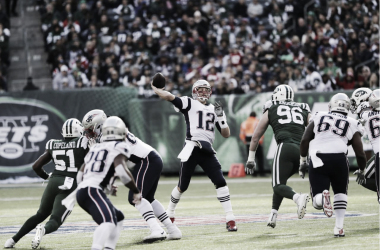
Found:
360,111 -> 380,154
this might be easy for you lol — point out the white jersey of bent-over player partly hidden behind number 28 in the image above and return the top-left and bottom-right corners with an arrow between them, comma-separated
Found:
125,132 -> 154,164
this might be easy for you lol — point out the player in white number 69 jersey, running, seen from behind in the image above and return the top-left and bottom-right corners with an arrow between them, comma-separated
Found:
300,93 -> 366,237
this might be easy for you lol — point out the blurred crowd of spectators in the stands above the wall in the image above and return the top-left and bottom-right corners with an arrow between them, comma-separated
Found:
35,0 -> 379,97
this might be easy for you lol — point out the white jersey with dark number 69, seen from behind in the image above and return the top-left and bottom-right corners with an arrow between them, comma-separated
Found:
309,112 -> 364,154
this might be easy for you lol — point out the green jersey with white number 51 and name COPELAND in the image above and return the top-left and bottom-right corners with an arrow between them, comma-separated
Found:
46,136 -> 88,178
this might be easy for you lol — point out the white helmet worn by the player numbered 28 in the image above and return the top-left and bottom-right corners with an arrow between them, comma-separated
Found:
102,116 -> 128,141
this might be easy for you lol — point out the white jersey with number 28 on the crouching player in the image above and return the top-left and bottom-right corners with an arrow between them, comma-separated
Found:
79,141 -> 130,188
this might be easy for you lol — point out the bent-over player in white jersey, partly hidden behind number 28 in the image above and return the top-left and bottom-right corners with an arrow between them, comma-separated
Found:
82,110 -> 178,242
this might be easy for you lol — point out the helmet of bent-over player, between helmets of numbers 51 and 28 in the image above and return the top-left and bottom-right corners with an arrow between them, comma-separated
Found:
82,109 -> 107,138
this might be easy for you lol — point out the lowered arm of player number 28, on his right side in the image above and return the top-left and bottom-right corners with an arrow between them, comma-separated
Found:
113,154 -> 142,204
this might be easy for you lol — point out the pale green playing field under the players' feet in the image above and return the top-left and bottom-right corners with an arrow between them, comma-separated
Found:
0,174 -> 379,250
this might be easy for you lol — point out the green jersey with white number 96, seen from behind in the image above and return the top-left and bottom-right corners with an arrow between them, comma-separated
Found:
263,101 -> 310,144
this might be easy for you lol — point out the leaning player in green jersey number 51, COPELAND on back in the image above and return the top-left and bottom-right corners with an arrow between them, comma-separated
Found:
4,118 -> 88,249
